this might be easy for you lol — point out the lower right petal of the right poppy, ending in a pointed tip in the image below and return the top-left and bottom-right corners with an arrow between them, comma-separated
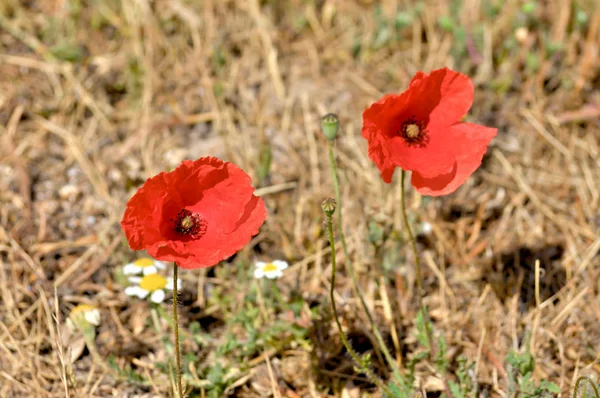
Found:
411,123 -> 498,196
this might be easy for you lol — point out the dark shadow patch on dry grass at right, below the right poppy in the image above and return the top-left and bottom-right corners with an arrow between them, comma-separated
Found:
483,244 -> 566,312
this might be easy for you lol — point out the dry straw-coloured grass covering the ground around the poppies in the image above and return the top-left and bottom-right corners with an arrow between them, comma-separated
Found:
0,0 -> 600,397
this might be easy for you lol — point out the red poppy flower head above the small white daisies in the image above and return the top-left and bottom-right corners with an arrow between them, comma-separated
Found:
121,157 -> 267,268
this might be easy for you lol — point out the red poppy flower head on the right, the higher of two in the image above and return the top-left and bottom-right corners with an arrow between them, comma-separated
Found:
362,68 -> 497,196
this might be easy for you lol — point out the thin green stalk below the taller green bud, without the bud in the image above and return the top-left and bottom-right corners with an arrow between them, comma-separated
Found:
327,140 -> 401,382
